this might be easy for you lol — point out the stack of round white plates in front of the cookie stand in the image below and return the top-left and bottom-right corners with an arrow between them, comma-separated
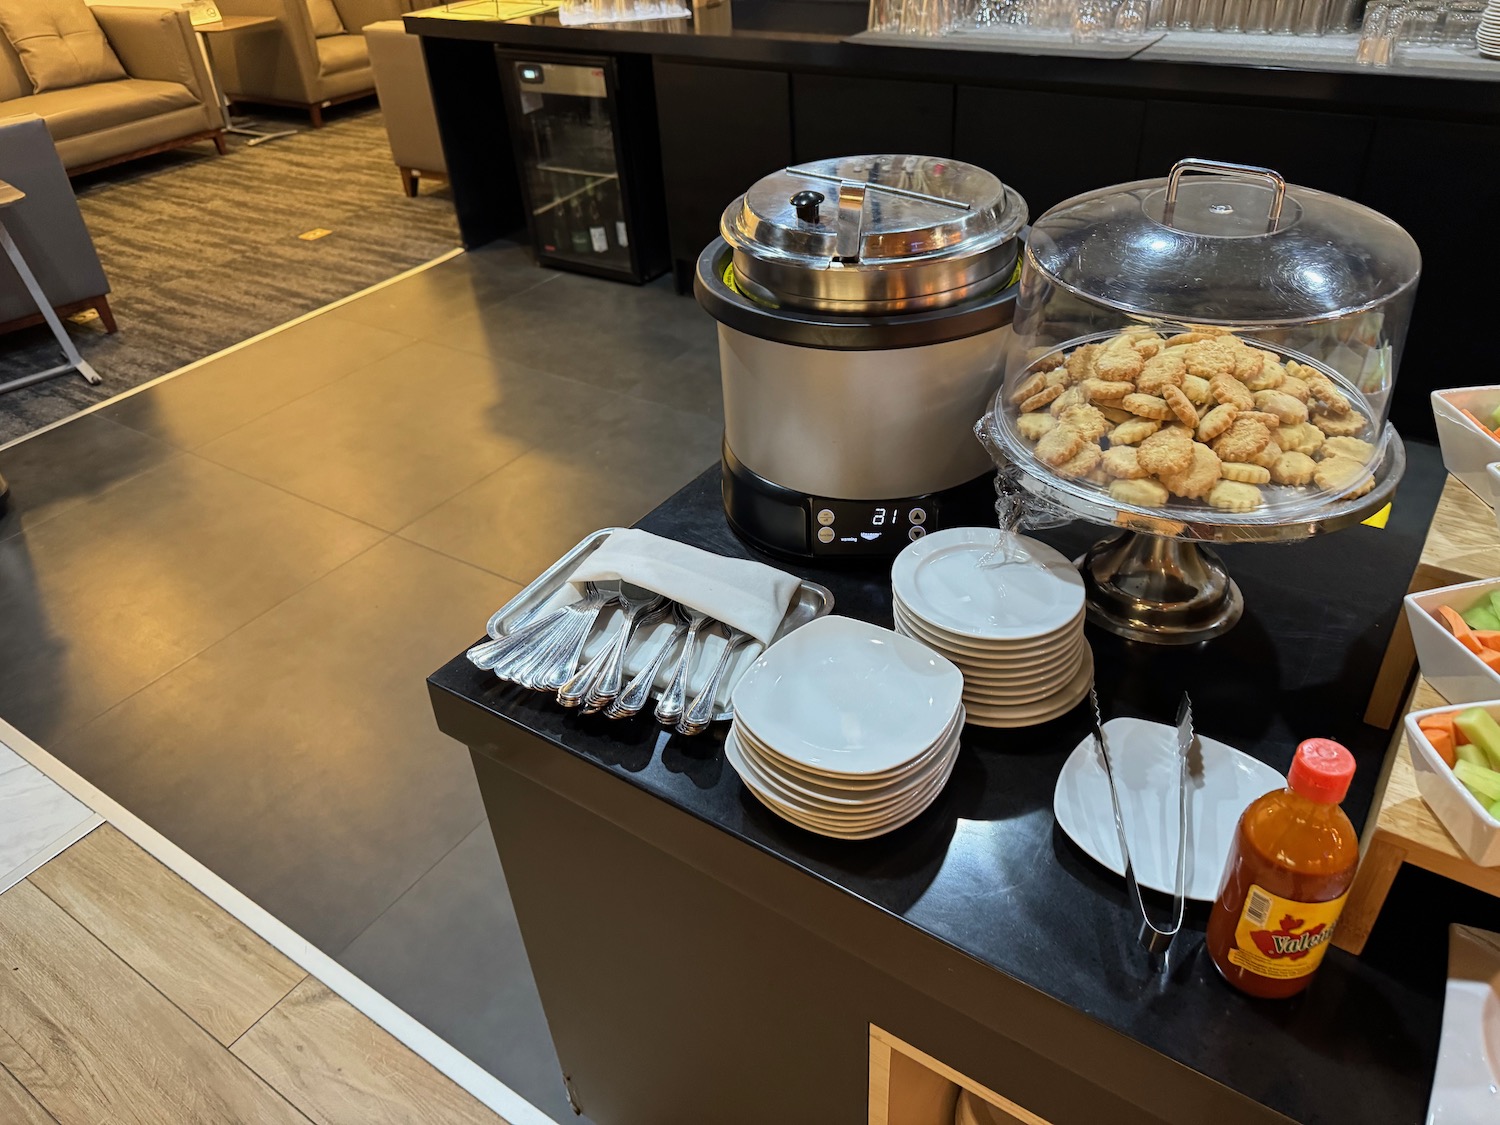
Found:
891,528 -> 1094,726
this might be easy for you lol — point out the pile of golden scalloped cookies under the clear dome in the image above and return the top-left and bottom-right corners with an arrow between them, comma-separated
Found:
1010,327 -> 1376,513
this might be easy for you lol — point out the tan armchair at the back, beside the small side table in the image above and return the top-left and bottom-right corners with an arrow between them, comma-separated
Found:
209,0 -> 411,128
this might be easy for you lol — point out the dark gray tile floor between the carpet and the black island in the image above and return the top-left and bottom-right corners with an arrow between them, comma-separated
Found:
0,246 -> 722,1121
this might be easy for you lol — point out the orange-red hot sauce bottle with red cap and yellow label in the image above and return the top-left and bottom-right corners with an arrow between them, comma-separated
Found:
1208,738 -> 1359,998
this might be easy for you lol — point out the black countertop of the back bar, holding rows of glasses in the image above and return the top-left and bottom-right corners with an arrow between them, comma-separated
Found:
405,0 -> 1500,119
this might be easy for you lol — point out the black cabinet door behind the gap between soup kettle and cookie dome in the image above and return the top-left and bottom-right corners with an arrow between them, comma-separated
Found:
953,86 -> 1146,219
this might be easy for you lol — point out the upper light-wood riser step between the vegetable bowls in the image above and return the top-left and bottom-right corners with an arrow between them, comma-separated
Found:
1365,476 -> 1500,728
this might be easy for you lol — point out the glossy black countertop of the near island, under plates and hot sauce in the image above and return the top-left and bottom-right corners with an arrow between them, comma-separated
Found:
431,444 -> 1476,1125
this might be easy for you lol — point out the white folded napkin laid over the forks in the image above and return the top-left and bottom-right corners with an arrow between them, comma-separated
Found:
570,528 -> 800,645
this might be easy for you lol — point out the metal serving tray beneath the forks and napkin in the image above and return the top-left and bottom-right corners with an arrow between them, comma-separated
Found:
488,528 -> 834,722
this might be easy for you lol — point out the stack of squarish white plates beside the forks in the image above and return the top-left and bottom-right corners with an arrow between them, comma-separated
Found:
725,617 -> 963,840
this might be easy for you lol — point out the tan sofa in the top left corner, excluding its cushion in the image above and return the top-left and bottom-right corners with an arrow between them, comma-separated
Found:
0,0 -> 225,176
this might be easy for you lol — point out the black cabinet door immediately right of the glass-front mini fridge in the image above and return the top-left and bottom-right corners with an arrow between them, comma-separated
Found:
656,62 -> 792,293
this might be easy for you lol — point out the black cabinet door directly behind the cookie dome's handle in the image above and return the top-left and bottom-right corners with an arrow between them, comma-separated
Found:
1137,102 -> 1376,197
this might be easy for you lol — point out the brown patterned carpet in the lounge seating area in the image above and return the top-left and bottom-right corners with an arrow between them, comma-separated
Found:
0,104 -> 459,444
